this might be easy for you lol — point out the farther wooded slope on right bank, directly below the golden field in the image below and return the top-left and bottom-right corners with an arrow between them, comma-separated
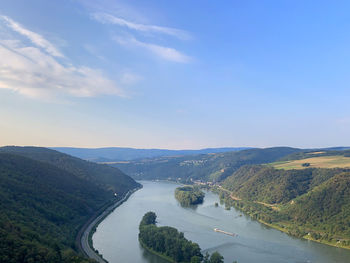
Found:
223,165 -> 346,204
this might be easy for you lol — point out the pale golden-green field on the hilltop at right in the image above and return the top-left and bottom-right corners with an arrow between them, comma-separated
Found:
271,155 -> 350,170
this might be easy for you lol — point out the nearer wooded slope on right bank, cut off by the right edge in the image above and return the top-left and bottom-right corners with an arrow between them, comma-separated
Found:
282,172 -> 350,239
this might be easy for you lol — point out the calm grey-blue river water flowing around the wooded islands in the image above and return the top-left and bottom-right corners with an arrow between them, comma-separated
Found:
93,181 -> 350,263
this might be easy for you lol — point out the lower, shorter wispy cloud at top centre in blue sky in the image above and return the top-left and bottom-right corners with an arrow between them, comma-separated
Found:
115,37 -> 192,63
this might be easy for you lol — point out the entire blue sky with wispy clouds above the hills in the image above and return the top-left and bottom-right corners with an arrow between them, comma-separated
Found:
0,0 -> 350,149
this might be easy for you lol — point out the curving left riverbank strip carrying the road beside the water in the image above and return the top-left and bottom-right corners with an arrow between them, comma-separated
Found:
76,187 -> 142,263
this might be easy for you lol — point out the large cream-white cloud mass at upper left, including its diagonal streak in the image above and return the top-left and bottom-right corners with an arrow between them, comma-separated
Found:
0,17 -> 125,99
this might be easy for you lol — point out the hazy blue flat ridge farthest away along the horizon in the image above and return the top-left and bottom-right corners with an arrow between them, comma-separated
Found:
51,147 -> 248,162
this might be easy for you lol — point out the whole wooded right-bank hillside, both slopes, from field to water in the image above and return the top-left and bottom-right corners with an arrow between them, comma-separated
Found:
218,165 -> 350,247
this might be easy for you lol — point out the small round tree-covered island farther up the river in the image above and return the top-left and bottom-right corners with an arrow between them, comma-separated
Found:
175,186 -> 205,206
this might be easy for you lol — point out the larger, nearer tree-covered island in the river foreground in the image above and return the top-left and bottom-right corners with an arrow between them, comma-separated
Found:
139,212 -> 224,263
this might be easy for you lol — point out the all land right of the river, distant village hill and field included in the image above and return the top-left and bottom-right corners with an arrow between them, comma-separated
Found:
110,148 -> 350,253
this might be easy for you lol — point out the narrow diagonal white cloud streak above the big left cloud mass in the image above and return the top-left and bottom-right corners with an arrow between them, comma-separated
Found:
0,16 -> 63,57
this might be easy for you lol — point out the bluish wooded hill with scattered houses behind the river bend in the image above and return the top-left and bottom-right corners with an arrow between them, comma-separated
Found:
113,147 -> 301,182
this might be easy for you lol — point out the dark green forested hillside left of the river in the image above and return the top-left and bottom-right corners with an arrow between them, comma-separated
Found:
0,147 -> 138,263
